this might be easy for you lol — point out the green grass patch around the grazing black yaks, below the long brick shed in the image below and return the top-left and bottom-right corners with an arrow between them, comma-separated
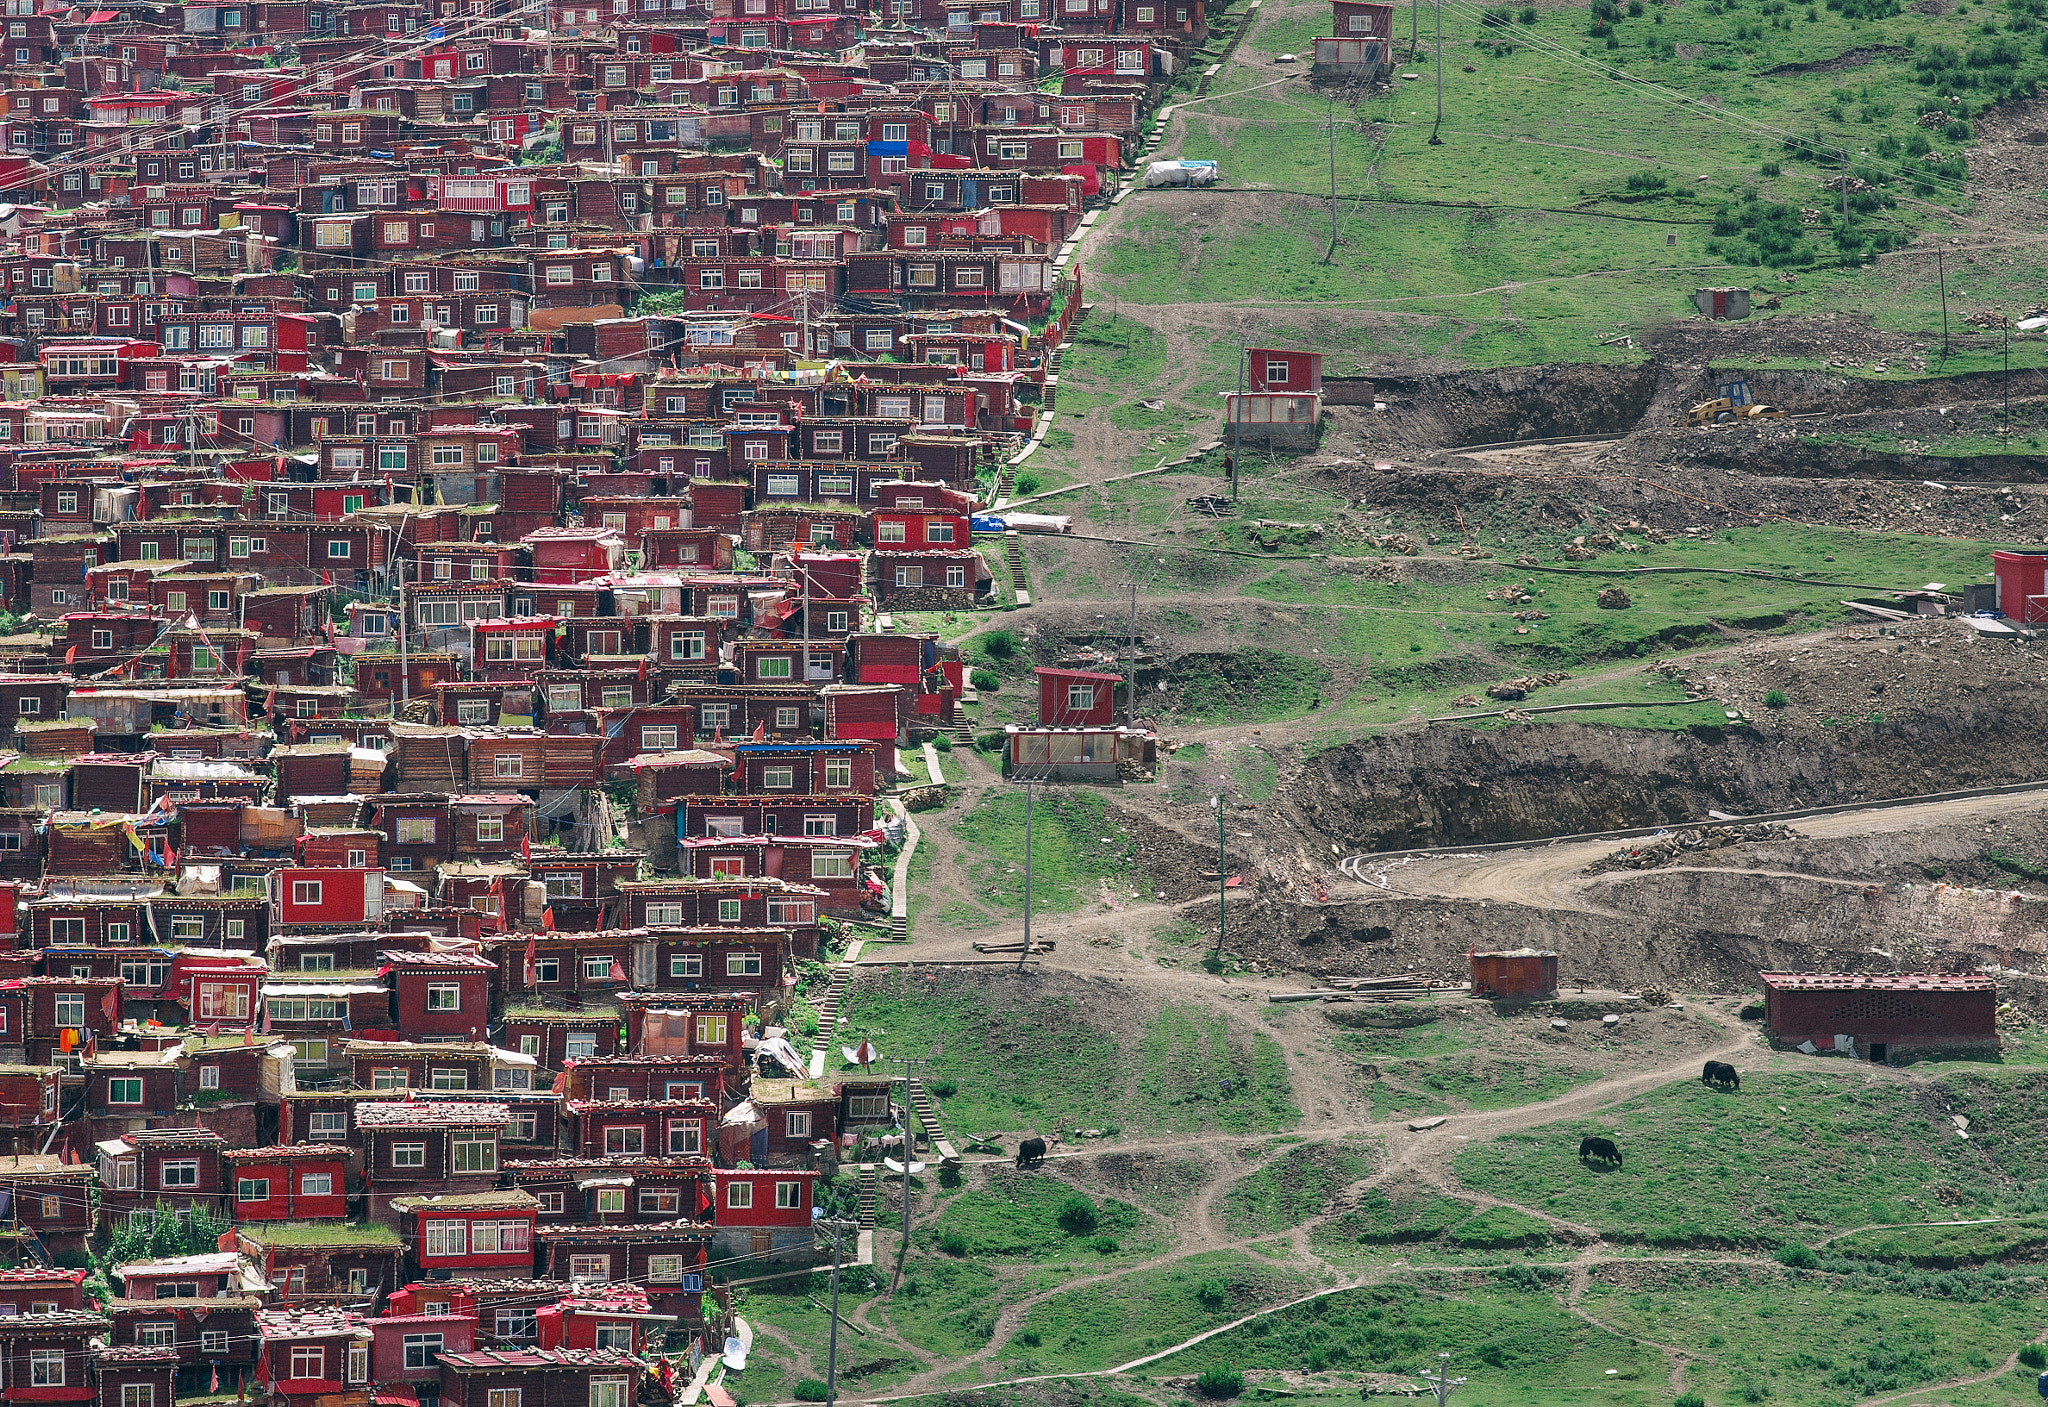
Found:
1452,1071 -> 1997,1247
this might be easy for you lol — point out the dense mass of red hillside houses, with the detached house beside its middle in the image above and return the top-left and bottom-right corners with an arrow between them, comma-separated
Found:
0,0 -> 1253,1376
